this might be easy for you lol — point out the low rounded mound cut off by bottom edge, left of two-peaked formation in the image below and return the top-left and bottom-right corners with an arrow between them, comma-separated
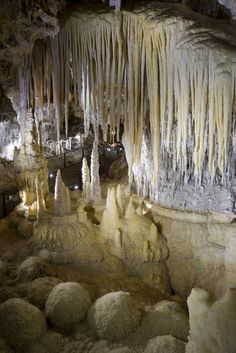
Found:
144,336 -> 186,353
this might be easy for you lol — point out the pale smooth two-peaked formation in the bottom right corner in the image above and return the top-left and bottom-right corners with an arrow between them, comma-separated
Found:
187,288 -> 236,353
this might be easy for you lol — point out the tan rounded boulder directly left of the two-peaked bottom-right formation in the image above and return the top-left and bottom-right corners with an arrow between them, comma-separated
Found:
135,300 -> 189,343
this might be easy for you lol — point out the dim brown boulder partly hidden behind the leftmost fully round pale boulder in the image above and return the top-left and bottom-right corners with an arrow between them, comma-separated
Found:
27,277 -> 62,309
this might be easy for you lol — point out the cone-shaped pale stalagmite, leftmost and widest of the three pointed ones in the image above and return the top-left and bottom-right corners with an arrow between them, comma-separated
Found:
54,169 -> 71,216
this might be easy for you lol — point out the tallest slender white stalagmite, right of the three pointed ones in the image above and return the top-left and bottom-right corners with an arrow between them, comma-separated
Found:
90,140 -> 101,202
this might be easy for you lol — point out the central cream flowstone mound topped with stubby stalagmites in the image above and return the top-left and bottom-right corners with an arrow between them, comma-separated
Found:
99,187 -> 170,294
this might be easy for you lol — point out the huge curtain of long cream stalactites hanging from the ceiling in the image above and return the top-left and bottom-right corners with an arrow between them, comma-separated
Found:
18,4 -> 236,198
